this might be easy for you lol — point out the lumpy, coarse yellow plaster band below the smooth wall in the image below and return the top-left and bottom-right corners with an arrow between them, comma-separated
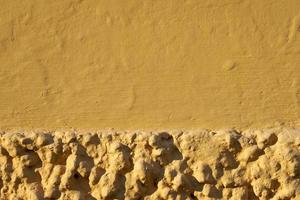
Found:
0,129 -> 300,200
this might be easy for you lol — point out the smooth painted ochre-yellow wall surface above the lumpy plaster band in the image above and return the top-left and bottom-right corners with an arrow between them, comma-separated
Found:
0,0 -> 300,129
